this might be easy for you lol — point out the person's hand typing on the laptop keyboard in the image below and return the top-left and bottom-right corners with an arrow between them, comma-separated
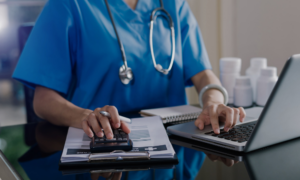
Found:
195,103 -> 246,134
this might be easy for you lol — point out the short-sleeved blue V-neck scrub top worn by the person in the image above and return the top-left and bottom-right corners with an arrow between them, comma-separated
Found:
13,0 -> 211,112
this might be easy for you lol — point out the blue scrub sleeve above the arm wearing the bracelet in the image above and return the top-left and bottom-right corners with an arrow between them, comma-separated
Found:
179,1 -> 211,86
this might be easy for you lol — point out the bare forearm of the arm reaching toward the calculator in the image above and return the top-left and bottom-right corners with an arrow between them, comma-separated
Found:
33,86 -> 93,128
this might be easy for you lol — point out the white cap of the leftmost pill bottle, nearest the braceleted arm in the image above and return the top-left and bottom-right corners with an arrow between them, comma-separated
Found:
220,57 -> 242,73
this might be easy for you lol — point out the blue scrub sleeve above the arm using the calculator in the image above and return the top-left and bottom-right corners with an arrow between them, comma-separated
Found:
13,0 -> 76,94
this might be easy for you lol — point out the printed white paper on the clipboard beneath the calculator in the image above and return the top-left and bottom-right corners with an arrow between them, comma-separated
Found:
61,116 -> 175,163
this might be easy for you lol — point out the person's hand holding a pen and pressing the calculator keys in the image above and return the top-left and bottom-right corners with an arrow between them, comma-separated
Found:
82,106 -> 130,139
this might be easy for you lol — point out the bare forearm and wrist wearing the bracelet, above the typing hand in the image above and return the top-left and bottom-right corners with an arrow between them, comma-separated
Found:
192,70 -> 224,108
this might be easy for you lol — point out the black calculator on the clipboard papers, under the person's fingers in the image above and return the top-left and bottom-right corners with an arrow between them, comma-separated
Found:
90,129 -> 132,153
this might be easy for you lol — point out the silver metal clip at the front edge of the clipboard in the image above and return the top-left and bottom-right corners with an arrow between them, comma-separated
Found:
88,150 -> 150,162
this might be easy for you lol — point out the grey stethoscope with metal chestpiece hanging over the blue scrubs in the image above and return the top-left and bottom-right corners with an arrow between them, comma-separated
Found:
105,0 -> 175,85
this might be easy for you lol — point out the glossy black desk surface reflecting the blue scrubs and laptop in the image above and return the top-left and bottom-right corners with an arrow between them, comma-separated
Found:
0,122 -> 300,180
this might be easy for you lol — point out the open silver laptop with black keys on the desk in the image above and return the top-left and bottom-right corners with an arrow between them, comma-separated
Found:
167,54 -> 300,152
